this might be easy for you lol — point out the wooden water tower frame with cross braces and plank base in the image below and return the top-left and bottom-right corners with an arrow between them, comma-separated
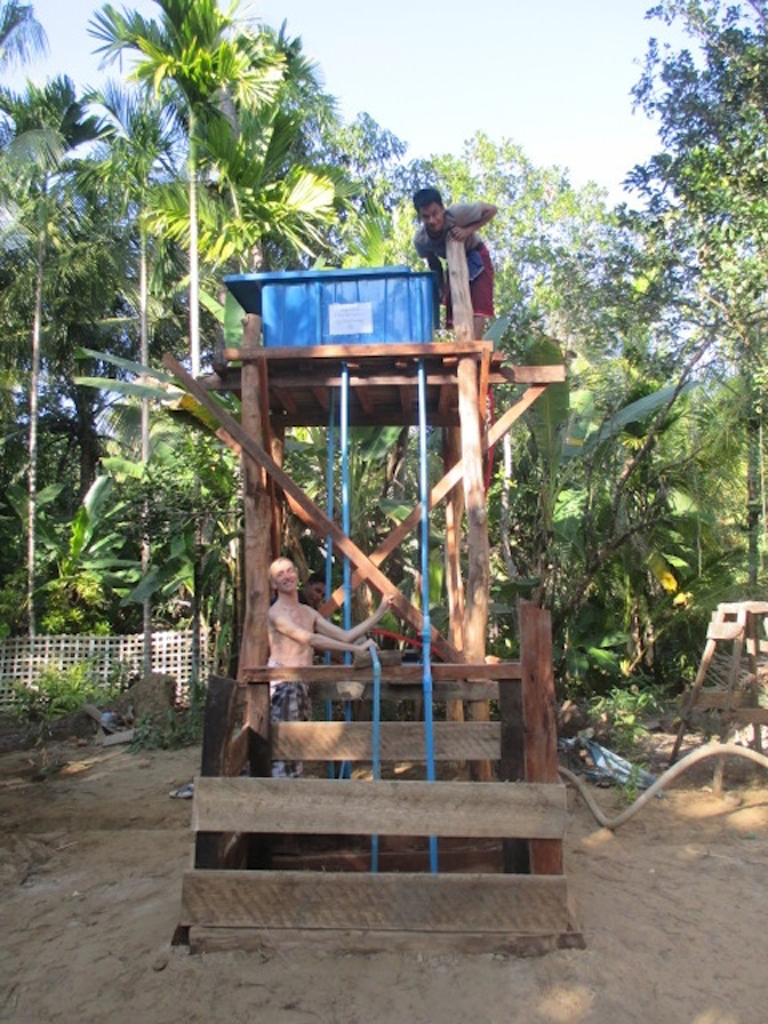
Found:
165,247 -> 583,953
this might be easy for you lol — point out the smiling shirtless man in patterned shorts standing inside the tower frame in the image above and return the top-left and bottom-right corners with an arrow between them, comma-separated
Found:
267,558 -> 392,778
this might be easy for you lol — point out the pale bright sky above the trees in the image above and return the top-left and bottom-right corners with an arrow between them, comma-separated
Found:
4,0 -> 683,203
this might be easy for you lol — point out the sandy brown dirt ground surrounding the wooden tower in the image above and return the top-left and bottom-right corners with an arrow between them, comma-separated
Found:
0,740 -> 768,1024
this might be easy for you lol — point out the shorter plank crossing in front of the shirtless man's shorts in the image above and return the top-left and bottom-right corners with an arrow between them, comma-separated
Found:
272,722 -> 501,761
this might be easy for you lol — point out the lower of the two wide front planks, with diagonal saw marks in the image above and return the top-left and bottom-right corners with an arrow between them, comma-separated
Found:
180,870 -> 569,934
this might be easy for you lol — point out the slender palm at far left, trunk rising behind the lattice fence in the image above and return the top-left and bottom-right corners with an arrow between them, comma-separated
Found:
0,78 -> 98,636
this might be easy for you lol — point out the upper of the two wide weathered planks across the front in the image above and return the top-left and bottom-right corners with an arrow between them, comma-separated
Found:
193,777 -> 566,840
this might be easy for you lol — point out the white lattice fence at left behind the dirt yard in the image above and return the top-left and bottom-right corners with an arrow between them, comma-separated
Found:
0,630 -> 211,705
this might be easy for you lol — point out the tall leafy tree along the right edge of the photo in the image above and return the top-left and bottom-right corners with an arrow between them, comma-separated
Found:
632,0 -> 768,590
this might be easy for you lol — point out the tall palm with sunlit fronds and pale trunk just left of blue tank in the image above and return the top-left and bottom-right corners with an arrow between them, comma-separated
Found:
90,0 -> 285,376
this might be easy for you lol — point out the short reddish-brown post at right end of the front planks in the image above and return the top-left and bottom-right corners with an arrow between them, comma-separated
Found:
520,601 -> 563,874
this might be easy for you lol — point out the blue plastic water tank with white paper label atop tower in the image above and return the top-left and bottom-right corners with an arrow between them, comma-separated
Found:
224,266 -> 433,347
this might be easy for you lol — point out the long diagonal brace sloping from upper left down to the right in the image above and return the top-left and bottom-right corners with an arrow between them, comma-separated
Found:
163,354 -> 463,665
